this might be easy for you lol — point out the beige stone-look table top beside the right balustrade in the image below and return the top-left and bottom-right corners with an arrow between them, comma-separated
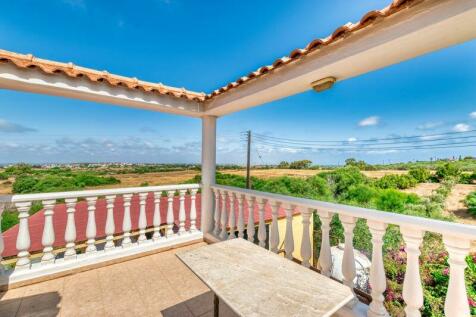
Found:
176,239 -> 353,317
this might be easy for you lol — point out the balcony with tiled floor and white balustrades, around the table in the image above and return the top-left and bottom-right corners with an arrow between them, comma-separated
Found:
0,184 -> 476,316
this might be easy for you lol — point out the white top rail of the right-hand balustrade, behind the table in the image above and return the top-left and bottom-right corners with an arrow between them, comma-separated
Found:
211,185 -> 476,240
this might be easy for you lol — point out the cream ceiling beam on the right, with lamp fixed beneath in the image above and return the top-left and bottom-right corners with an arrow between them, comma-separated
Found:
205,0 -> 476,116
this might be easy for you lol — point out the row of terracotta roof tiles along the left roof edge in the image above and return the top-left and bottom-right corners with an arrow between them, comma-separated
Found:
0,50 -> 205,101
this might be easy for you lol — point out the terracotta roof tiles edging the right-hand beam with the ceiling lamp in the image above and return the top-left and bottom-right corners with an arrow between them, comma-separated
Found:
206,0 -> 425,99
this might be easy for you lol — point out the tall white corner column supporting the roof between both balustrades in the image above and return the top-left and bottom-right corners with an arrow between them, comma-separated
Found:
201,116 -> 217,234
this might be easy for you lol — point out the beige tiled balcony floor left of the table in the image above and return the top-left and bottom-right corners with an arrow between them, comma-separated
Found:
0,243 -> 238,317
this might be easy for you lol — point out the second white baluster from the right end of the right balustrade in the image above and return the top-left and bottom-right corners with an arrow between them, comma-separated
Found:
400,227 -> 423,317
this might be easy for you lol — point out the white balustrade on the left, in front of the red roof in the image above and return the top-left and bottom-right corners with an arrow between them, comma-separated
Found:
0,184 -> 202,284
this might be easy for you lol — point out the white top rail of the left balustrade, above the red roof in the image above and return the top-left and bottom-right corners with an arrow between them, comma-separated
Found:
7,184 -> 200,203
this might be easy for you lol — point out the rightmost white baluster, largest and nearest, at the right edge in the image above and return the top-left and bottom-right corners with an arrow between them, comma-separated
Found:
443,236 -> 470,317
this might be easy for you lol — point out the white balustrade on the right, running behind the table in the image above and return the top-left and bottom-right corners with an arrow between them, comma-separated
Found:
212,185 -> 476,317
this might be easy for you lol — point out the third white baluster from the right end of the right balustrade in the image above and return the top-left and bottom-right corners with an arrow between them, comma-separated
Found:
367,220 -> 388,317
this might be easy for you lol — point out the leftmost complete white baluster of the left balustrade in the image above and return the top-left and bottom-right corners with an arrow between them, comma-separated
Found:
15,202 -> 31,269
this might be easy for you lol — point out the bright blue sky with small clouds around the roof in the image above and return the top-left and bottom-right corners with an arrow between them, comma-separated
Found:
0,0 -> 476,164
